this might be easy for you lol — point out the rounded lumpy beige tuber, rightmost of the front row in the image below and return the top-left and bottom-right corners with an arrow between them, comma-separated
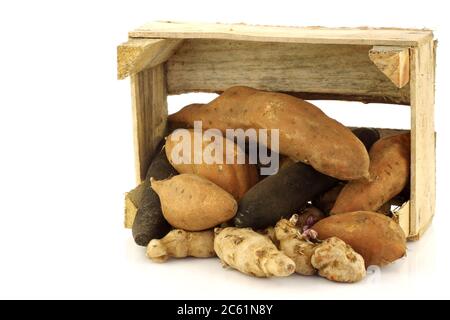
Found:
311,237 -> 366,282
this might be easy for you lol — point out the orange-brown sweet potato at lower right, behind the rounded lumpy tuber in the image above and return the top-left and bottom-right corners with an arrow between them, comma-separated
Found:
313,211 -> 406,266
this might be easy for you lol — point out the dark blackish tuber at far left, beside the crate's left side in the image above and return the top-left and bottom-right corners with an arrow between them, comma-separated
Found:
132,147 -> 178,246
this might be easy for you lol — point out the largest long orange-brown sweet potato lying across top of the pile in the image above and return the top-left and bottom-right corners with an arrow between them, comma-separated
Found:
169,87 -> 369,180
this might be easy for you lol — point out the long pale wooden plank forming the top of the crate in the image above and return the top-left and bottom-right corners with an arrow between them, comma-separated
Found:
129,21 -> 433,46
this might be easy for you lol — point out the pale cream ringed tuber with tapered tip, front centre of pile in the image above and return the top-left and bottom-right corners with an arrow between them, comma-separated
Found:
214,227 -> 295,277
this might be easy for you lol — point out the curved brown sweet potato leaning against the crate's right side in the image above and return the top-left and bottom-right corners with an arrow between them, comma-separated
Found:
331,133 -> 411,214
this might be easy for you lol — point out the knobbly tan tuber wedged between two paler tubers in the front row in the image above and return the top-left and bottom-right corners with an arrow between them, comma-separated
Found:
275,214 -> 316,276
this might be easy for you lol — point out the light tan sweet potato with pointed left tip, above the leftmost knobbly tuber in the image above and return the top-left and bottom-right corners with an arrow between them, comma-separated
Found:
151,174 -> 237,231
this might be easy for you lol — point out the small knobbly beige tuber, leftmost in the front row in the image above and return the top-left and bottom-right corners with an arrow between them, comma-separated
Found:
147,229 -> 216,262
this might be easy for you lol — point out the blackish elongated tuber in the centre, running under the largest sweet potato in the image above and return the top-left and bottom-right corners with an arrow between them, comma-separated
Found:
233,128 -> 379,229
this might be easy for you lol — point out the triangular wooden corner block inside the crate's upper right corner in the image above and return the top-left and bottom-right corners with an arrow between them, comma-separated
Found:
369,46 -> 409,88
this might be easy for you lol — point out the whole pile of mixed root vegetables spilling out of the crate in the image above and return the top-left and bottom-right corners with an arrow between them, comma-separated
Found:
126,87 -> 410,282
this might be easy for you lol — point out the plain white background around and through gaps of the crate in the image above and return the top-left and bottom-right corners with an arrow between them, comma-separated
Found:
0,0 -> 450,299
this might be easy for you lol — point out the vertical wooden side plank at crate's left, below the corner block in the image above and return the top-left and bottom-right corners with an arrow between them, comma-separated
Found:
131,64 -> 167,183
